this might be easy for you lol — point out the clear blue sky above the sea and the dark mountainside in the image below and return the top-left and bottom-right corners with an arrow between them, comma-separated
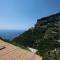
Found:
0,0 -> 60,30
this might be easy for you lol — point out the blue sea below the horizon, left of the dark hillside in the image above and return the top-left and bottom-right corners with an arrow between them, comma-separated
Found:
0,30 -> 24,41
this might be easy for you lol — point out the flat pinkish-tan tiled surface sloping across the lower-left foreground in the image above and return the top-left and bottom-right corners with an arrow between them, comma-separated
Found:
0,40 -> 42,60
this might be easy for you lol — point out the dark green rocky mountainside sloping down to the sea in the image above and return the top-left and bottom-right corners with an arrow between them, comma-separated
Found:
13,13 -> 60,53
